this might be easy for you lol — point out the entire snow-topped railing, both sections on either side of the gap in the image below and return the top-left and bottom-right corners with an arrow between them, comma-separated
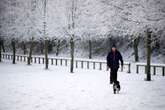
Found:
2,53 -> 165,76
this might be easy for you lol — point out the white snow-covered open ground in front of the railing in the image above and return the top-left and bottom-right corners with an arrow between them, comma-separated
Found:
0,61 -> 165,110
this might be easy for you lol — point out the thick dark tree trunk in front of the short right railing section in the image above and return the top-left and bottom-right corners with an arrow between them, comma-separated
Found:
146,30 -> 151,81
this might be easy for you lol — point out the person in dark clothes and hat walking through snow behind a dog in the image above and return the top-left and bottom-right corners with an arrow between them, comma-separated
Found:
107,45 -> 123,84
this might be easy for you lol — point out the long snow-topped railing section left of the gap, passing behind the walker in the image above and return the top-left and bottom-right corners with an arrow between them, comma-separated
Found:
2,53 -> 131,73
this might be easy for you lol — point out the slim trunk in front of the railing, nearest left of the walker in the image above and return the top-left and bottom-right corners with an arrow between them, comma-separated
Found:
70,35 -> 74,73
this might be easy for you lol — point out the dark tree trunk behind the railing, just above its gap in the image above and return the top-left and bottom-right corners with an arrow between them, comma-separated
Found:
133,37 -> 139,62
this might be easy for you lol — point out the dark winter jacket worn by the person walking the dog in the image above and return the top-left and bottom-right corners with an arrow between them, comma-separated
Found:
107,50 -> 123,68
